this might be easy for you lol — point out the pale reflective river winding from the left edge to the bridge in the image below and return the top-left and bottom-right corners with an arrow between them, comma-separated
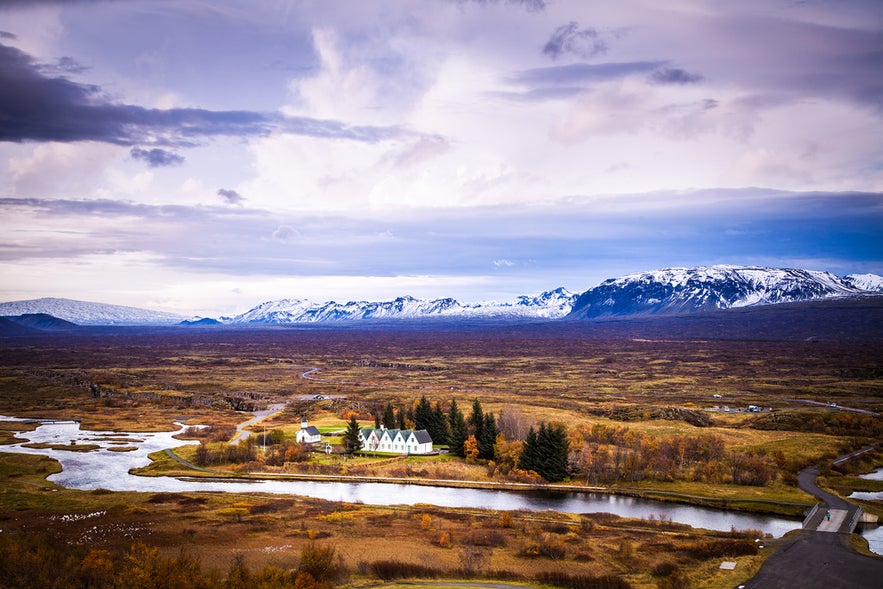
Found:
0,416 -> 800,537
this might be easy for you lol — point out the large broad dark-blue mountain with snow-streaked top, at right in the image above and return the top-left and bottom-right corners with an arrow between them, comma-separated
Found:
568,265 -> 880,319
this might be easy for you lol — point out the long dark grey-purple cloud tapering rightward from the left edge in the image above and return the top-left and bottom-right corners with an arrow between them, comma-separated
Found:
0,44 -> 401,147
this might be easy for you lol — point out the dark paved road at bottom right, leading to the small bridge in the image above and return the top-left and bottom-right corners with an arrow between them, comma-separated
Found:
742,468 -> 883,589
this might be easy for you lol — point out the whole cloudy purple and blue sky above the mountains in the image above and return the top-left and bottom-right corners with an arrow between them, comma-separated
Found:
0,0 -> 883,316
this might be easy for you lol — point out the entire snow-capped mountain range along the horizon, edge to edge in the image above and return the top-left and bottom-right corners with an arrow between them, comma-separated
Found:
0,265 -> 883,329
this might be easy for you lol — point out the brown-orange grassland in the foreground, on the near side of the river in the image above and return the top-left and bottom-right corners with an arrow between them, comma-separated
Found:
0,454 -> 762,587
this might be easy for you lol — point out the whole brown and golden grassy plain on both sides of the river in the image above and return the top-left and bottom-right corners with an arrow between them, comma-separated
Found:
0,330 -> 883,589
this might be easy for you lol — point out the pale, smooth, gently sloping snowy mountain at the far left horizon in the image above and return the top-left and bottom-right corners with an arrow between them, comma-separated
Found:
0,298 -> 185,325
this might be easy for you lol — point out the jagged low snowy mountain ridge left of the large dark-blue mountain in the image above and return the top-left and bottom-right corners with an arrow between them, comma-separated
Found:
229,288 -> 576,324
